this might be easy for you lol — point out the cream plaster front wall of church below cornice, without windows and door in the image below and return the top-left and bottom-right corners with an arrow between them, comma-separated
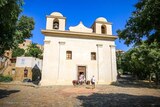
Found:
41,36 -> 116,85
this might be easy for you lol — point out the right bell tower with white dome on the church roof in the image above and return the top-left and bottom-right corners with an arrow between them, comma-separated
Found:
92,17 -> 112,35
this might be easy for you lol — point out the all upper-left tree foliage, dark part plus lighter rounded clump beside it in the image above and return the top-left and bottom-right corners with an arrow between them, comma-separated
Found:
0,0 -> 34,55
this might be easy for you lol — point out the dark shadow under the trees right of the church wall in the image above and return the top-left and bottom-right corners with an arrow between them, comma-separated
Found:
111,76 -> 160,89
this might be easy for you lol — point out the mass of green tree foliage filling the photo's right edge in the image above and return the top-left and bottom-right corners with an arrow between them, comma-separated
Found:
117,0 -> 160,83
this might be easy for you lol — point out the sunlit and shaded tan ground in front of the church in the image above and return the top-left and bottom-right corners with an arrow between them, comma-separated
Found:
0,81 -> 160,107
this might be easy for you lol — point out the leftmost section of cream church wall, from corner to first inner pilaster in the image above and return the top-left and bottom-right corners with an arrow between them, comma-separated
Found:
41,39 -> 59,85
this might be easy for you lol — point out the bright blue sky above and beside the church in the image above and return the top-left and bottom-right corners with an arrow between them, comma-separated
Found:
22,0 -> 138,51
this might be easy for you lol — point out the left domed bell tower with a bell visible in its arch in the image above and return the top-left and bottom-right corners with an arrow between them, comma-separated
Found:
46,12 -> 66,31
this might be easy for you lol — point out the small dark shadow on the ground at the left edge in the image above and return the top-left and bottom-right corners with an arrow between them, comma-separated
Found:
0,89 -> 20,99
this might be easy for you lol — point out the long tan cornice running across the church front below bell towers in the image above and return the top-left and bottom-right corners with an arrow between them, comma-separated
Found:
41,30 -> 118,41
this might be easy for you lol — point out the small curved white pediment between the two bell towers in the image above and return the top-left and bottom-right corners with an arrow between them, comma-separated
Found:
69,22 -> 93,33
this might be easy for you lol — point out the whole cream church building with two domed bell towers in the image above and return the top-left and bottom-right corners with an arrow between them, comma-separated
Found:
40,12 -> 117,86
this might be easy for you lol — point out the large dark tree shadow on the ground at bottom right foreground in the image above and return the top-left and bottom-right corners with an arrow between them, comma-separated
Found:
77,93 -> 160,107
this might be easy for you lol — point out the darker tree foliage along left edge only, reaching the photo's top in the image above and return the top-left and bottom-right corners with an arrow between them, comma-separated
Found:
0,0 -> 22,55
